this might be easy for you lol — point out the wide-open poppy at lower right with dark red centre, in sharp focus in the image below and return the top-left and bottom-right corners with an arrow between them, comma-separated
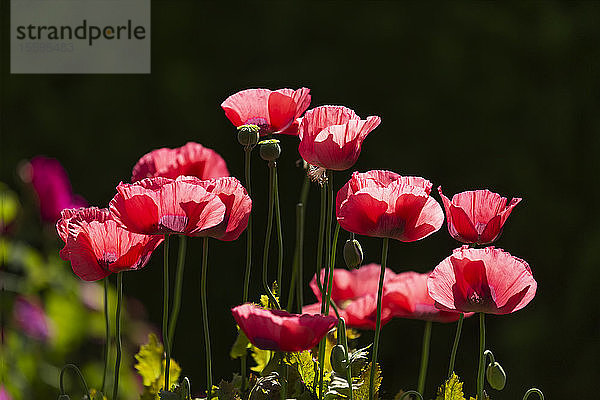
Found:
427,246 -> 537,314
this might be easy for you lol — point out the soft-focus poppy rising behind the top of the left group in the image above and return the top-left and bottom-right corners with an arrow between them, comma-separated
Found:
131,142 -> 229,182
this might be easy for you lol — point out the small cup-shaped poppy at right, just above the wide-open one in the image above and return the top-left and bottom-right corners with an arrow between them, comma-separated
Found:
438,186 -> 521,244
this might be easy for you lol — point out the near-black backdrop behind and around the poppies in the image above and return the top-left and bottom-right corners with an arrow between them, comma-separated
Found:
0,1 -> 600,399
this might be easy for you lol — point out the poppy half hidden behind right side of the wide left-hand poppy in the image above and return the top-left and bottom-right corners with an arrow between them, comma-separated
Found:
197,177 -> 252,241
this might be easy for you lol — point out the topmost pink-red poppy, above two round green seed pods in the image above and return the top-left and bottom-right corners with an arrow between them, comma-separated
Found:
221,88 -> 310,135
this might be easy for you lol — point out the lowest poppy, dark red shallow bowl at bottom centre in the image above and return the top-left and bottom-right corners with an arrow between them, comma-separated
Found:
231,303 -> 337,352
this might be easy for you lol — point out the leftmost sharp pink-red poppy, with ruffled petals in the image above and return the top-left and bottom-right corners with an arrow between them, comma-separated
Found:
56,208 -> 163,281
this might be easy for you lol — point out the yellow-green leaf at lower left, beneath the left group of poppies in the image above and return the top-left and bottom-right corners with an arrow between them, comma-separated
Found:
135,333 -> 181,400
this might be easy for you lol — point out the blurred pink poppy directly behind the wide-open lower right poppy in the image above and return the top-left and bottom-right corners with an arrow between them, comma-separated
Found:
382,271 -> 471,322
